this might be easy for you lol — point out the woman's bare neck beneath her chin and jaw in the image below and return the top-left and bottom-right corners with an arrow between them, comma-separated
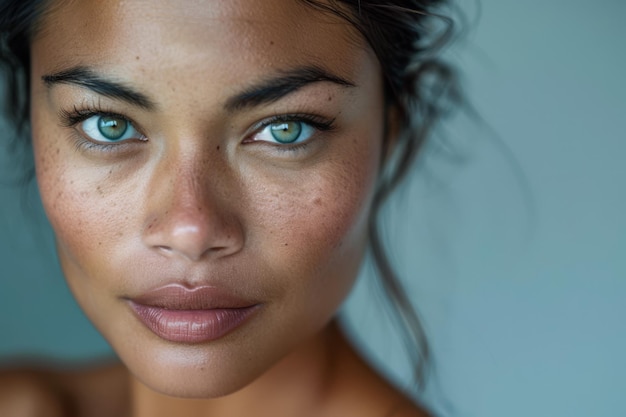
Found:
131,323 -> 350,417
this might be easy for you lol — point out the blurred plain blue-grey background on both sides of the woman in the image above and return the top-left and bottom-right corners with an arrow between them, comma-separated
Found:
0,0 -> 626,417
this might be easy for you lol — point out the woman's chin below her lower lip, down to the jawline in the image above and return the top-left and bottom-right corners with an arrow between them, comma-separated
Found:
105,308 -> 316,399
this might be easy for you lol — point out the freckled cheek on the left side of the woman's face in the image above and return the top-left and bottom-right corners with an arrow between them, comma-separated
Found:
33,117 -> 128,279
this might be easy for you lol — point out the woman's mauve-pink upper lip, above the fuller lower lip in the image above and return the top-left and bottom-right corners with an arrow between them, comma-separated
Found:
130,284 -> 258,310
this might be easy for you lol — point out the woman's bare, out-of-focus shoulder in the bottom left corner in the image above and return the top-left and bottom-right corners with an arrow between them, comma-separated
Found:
0,358 -> 128,417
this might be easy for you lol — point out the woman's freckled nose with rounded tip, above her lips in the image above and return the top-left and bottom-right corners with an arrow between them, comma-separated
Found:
143,151 -> 244,261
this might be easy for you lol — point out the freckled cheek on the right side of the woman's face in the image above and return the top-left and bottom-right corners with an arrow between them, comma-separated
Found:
244,133 -> 380,318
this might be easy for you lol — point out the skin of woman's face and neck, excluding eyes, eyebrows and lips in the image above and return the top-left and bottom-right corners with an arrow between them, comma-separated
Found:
15,0 -> 422,416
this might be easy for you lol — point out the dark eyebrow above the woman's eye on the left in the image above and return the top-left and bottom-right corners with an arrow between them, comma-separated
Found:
41,66 -> 157,110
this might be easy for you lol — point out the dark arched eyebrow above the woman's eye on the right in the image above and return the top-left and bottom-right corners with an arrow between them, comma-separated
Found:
224,66 -> 356,112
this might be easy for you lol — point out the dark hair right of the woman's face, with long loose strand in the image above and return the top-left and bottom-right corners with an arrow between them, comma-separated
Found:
304,0 -> 460,391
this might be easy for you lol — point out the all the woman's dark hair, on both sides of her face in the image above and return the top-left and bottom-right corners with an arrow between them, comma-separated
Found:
0,0 -> 460,406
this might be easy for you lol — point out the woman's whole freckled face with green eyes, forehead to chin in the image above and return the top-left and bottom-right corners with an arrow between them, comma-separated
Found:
31,0 -> 384,396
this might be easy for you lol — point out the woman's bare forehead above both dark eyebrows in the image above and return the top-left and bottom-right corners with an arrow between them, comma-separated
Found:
33,0 -> 367,82
